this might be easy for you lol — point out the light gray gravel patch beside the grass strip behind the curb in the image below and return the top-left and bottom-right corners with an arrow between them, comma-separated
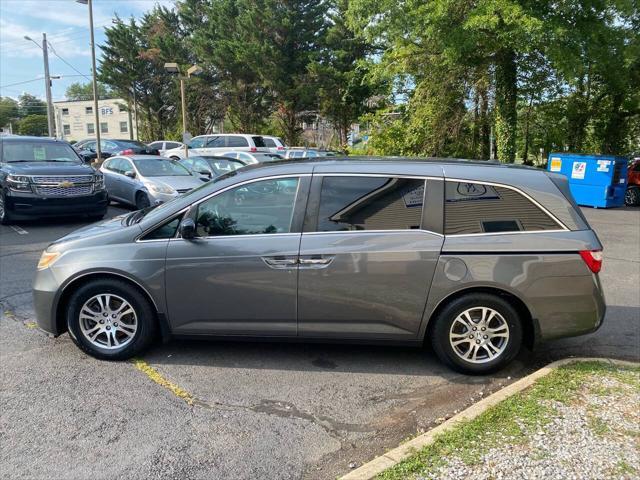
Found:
418,375 -> 640,480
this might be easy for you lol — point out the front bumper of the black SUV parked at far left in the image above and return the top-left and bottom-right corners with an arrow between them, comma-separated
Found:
5,190 -> 109,218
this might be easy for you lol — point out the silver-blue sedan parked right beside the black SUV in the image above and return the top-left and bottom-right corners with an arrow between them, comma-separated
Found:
100,155 -> 203,209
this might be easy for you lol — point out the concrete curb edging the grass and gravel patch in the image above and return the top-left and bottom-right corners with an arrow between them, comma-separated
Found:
340,357 -> 640,480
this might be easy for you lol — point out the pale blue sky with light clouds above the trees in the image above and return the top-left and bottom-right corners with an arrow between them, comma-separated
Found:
0,0 -> 174,101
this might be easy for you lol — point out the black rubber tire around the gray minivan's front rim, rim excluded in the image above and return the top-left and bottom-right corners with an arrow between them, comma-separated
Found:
67,278 -> 158,360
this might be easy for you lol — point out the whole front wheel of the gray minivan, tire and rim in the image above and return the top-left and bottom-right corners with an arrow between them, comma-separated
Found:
67,279 -> 157,360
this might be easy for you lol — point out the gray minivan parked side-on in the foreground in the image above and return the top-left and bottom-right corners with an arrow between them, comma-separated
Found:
34,158 -> 605,373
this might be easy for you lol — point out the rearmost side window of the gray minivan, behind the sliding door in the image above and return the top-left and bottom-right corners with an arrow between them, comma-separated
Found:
444,181 -> 561,235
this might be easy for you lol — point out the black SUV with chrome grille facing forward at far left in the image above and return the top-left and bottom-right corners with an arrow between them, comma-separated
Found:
0,136 -> 109,225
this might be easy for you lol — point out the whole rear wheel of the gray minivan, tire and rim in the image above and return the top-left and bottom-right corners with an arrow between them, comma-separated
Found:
431,293 -> 522,374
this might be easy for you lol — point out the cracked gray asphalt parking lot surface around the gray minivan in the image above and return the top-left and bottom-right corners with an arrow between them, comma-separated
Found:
0,206 -> 640,479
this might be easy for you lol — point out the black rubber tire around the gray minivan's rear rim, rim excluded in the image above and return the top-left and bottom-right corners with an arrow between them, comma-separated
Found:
431,293 -> 523,375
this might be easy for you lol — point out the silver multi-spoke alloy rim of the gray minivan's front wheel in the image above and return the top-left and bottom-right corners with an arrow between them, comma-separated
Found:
80,293 -> 138,350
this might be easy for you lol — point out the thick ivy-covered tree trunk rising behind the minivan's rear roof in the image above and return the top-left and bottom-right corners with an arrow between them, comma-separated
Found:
495,49 -> 518,163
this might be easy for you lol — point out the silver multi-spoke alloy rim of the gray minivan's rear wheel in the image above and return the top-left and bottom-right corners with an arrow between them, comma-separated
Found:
449,307 -> 509,363
